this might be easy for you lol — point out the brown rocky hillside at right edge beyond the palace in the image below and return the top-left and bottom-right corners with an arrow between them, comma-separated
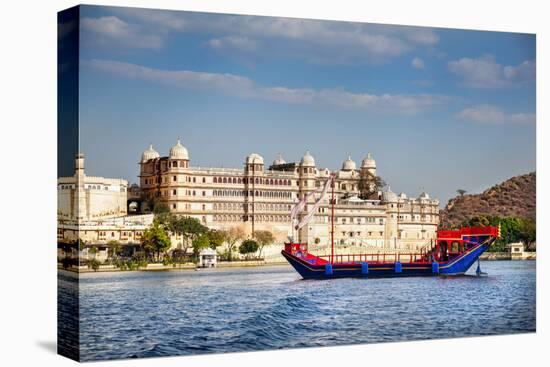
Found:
440,172 -> 537,228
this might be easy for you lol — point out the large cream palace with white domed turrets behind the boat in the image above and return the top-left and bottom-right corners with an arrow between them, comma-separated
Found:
139,140 -> 439,250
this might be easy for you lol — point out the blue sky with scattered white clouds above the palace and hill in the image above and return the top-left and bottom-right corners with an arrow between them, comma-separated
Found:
67,6 -> 536,205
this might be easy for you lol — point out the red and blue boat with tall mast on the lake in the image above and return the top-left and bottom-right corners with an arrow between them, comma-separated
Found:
281,176 -> 500,279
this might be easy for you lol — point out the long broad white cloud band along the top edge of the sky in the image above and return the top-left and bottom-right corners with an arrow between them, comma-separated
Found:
102,8 -> 439,63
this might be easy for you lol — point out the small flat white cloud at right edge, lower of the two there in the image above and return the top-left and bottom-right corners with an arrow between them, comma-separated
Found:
457,104 -> 536,124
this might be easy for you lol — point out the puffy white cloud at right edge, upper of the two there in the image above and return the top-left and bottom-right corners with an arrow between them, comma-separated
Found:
448,55 -> 536,88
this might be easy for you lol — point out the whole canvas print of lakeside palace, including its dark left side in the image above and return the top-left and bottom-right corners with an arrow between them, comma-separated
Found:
57,6 -> 536,361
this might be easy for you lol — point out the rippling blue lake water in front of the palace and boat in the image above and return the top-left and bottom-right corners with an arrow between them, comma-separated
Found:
60,261 -> 536,360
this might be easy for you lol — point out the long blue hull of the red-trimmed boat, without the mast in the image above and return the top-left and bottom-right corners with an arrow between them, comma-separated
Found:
281,242 -> 490,279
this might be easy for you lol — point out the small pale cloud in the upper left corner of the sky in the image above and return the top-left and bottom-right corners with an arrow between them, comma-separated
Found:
80,16 -> 162,50
